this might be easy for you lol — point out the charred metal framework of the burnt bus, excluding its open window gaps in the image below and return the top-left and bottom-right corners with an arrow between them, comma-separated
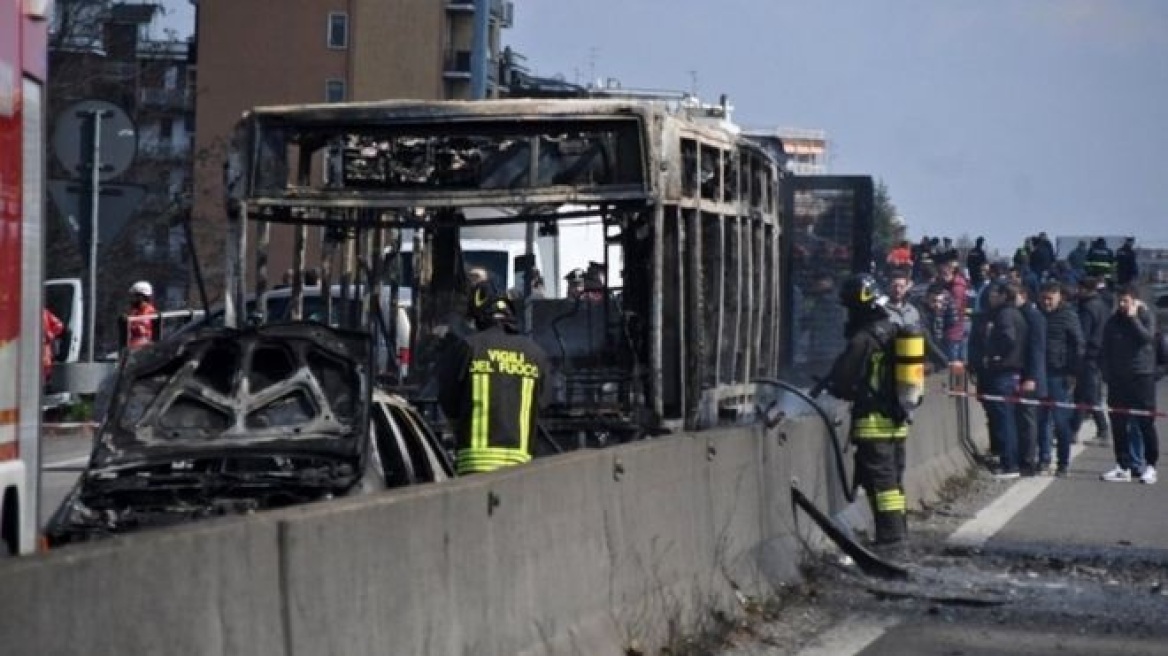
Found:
225,100 -> 785,439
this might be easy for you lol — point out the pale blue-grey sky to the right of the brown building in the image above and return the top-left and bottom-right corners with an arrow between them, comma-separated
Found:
502,0 -> 1168,252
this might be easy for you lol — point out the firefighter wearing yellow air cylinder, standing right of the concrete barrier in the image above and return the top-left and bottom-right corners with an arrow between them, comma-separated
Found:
825,274 -> 909,554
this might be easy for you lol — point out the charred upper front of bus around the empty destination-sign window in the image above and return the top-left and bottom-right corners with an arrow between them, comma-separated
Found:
228,99 -> 773,223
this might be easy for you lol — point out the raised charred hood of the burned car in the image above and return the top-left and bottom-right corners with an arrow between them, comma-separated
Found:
90,323 -> 370,464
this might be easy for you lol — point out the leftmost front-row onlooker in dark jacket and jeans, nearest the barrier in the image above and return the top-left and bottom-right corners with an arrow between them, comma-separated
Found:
979,282 -> 1028,479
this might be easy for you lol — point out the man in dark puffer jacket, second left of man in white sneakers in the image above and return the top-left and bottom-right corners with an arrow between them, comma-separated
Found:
1038,280 -> 1083,476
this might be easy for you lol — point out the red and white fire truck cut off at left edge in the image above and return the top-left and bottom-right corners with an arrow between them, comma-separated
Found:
0,0 -> 50,554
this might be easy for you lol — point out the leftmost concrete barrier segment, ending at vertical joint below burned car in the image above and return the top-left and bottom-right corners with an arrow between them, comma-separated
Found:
0,517 -> 287,656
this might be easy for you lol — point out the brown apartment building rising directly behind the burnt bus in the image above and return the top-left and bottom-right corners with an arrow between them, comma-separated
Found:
192,0 -> 513,288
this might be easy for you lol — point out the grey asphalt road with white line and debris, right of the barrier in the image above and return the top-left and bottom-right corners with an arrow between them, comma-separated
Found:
711,381 -> 1168,656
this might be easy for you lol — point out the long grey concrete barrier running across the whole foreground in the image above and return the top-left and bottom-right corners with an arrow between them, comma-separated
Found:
0,373 -> 983,656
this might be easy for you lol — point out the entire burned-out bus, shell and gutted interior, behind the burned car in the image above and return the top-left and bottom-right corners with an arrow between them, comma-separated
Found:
219,99 -> 781,447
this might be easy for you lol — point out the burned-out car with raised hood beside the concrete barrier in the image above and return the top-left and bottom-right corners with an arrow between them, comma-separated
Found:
46,323 -> 453,545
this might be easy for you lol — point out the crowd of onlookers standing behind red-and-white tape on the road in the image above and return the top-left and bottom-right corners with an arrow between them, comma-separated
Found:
883,232 -> 1159,484
